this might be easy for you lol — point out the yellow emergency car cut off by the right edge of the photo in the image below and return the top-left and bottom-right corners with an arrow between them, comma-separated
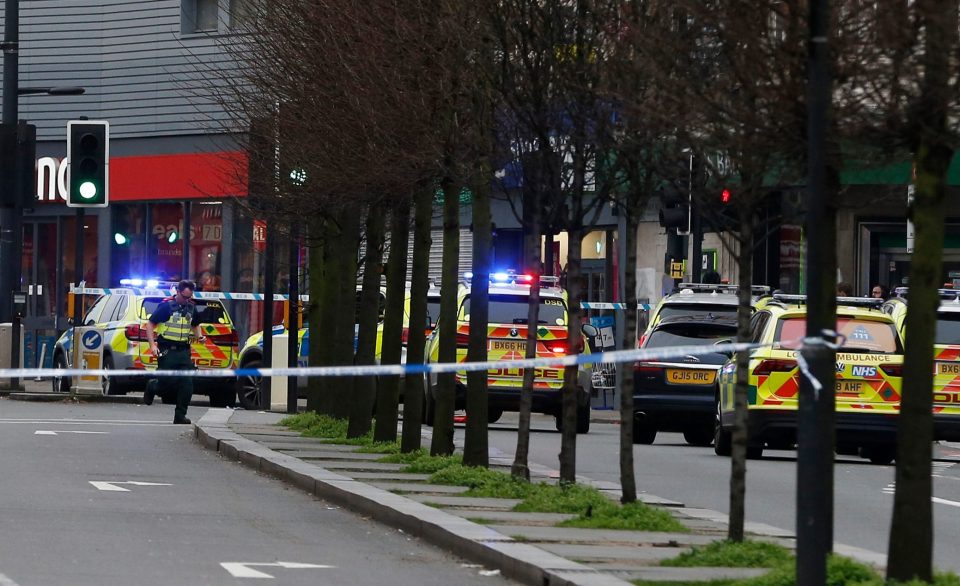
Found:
883,287 -> 960,442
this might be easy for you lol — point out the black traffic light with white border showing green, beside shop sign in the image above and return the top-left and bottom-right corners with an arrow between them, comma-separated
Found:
67,120 -> 110,208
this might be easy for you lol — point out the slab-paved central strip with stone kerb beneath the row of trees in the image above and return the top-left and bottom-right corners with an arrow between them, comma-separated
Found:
194,409 -> 885,586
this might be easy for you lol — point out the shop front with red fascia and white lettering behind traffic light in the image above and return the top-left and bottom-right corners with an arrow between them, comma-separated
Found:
20,152 -> 262,365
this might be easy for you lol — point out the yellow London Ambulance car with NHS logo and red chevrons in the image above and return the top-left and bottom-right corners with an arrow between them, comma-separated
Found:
714,295 -> 903,464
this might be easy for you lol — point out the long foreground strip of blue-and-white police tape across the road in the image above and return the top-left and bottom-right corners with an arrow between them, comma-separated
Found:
0,342 -> 770,378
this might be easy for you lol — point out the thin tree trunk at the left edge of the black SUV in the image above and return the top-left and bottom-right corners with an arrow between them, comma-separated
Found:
617,206 -> 640,504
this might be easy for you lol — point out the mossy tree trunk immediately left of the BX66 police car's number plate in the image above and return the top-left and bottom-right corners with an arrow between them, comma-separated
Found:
430,178 -> 460,456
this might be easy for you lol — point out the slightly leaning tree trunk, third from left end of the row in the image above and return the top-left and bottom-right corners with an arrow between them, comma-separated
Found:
348,206 -> 385,438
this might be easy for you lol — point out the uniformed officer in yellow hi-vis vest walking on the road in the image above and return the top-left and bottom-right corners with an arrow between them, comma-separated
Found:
143,280 -> 204,423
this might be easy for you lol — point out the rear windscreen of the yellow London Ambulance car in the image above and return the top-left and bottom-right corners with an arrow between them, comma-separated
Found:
774,316 -> 902,354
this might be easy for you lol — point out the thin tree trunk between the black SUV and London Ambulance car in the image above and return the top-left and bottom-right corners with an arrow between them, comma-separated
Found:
727,217 -> 753,542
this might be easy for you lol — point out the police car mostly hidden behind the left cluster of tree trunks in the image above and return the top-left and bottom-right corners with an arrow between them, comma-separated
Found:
237,285 -> 440,409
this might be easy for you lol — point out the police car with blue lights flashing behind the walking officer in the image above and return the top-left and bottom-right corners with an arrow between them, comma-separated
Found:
53,279 -> 239,407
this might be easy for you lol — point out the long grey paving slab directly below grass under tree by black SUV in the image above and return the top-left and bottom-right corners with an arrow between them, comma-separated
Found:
490,525 -> 717,547
